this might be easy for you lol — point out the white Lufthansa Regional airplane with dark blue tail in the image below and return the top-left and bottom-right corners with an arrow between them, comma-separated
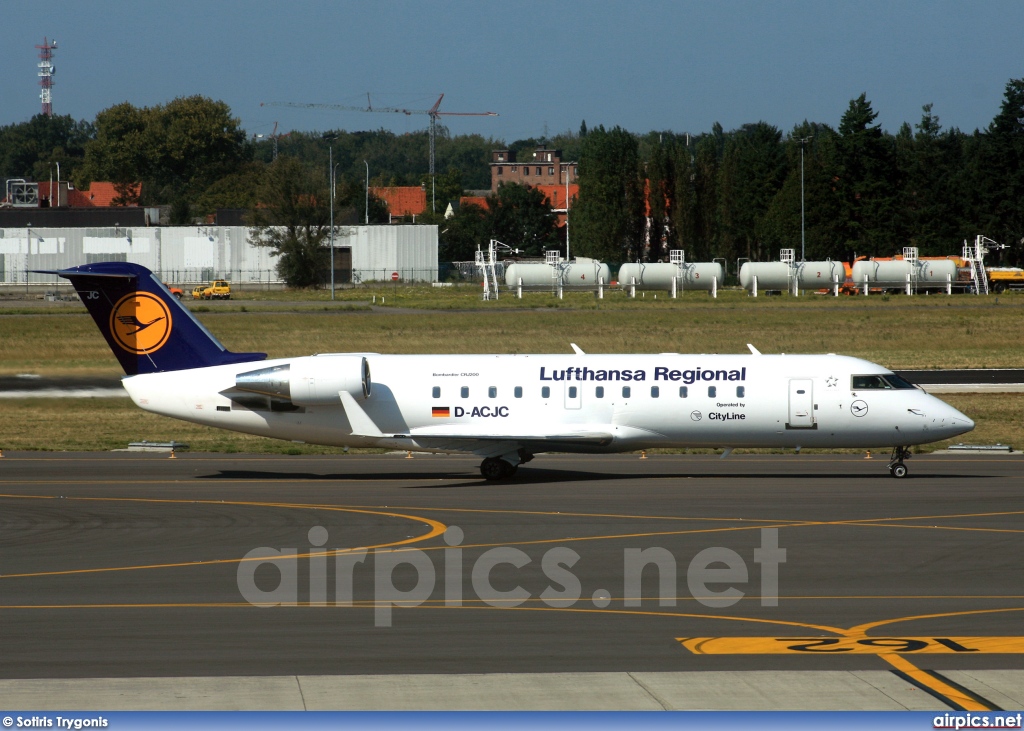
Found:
45,262 -> 974,480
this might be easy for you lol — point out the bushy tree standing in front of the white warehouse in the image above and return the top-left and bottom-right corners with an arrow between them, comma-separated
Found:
250,156 -> 331,288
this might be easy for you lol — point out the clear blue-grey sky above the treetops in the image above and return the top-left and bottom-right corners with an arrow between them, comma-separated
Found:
0,0 -> 1024,143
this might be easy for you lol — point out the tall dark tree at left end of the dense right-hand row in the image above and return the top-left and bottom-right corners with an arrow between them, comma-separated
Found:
569,126 -> 644,262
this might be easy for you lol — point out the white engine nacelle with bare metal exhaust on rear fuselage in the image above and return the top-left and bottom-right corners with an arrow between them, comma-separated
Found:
234,355 -> 372,406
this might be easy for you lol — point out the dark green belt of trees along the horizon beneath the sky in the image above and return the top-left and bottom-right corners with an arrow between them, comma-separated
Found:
6,79 -> 1024,268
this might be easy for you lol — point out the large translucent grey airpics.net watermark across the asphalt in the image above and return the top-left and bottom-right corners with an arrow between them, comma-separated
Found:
237,525 -> 786,627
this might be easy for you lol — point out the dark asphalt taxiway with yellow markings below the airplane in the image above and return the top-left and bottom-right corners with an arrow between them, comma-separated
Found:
0,453 -> 1024,707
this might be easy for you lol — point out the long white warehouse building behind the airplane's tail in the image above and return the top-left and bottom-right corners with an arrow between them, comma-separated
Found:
0,225 -> 437,288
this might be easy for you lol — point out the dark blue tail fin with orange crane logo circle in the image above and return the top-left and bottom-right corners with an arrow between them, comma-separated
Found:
41,262 -> 266,376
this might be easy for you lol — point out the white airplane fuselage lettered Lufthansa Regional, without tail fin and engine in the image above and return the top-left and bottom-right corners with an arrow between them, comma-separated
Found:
124,353 -> 974,455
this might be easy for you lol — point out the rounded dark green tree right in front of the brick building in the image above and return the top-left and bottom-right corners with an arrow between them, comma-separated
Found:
487,183 -> 557,256
